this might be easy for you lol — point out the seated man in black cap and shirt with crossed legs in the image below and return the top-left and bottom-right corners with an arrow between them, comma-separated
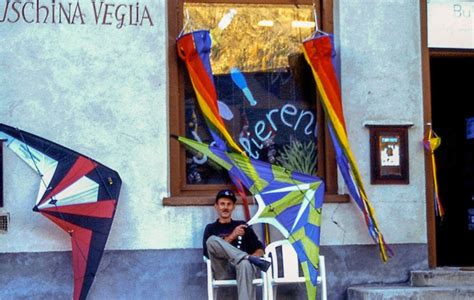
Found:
203,190 -> 270,300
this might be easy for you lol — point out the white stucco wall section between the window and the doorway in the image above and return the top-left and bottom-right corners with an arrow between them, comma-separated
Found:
322,0 -> 427,245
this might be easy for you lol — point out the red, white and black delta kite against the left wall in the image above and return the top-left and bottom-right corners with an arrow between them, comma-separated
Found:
0,124 -> 122,299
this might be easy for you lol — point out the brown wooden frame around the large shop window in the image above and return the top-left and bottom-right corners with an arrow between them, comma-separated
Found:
163,0 -> 349,206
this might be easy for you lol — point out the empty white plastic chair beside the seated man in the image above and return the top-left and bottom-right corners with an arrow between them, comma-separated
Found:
265,240 -> 327,300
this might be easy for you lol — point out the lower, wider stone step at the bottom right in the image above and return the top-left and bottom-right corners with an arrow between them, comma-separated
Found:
347,284 -> 474,300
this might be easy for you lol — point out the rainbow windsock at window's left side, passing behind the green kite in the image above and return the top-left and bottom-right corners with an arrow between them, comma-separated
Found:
177,30 -> 250,219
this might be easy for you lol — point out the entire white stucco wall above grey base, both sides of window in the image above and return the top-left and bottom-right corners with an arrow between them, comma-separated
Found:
0,0 -> 426,252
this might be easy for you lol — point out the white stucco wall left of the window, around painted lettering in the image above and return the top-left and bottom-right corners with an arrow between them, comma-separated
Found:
0,0 -> 184,252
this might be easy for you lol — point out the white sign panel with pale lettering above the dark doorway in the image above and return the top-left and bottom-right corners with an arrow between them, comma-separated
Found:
428,0 -> 474,49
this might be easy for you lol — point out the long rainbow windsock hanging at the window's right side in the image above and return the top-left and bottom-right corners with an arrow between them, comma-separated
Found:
303,34 -> 392,261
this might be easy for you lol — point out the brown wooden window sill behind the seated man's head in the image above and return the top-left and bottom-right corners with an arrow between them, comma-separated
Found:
163,194 -> 349,206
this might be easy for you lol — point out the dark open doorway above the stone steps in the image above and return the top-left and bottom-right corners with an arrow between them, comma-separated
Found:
430,57 -> 474,266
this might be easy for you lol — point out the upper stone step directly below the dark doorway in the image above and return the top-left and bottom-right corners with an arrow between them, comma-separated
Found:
410,268 -> 474,287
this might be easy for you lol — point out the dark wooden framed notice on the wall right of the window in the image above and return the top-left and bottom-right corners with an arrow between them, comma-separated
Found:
366,125 -> 412,184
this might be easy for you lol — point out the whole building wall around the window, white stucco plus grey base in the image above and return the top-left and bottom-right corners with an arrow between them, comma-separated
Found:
0,0 -> 458,299
